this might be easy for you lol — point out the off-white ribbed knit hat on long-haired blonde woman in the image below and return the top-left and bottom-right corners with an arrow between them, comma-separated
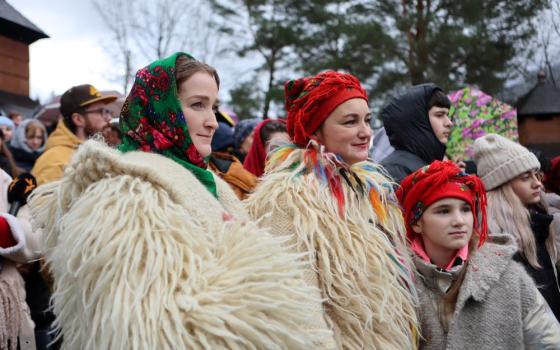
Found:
473,134 -> 541,191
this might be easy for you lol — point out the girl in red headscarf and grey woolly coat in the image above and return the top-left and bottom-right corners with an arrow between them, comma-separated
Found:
397,161 -> 560,350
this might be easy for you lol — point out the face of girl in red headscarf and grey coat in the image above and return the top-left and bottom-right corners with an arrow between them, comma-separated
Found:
412,198 -> 474,257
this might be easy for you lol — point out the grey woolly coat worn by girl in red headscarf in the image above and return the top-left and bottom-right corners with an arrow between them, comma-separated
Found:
415,235 -> 560,350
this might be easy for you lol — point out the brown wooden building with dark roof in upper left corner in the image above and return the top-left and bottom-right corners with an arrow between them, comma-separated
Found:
0,0 -> 48,116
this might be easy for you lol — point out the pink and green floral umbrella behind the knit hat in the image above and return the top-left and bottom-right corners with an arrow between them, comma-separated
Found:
447,87 -> 519,160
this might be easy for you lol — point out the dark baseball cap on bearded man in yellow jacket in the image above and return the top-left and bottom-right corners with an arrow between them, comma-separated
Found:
60,84 -> 118,116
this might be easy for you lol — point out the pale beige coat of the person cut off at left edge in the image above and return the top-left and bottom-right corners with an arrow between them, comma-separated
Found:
0,170 -> 41,350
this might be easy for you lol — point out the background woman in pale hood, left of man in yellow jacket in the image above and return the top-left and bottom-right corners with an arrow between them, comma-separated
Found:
10,119 -> 47,172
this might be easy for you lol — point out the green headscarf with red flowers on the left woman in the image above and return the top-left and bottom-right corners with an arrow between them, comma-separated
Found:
119,52 -> 218,197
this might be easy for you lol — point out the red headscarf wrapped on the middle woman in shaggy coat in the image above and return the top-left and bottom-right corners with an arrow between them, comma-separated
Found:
284,71 -> 368,147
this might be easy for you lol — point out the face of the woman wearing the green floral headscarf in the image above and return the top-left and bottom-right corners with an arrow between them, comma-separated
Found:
179,72 -> 222,157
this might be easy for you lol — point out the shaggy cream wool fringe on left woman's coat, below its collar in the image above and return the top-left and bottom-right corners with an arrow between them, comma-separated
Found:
31,142 -> 330,349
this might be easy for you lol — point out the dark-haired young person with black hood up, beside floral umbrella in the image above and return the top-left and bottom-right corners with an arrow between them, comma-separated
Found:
380,83 -> 453,183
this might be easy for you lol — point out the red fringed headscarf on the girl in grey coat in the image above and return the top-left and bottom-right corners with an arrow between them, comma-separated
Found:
397,160 -> 488,247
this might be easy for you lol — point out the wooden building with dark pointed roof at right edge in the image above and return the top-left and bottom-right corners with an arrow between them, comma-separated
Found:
517,72 -> 560,156
